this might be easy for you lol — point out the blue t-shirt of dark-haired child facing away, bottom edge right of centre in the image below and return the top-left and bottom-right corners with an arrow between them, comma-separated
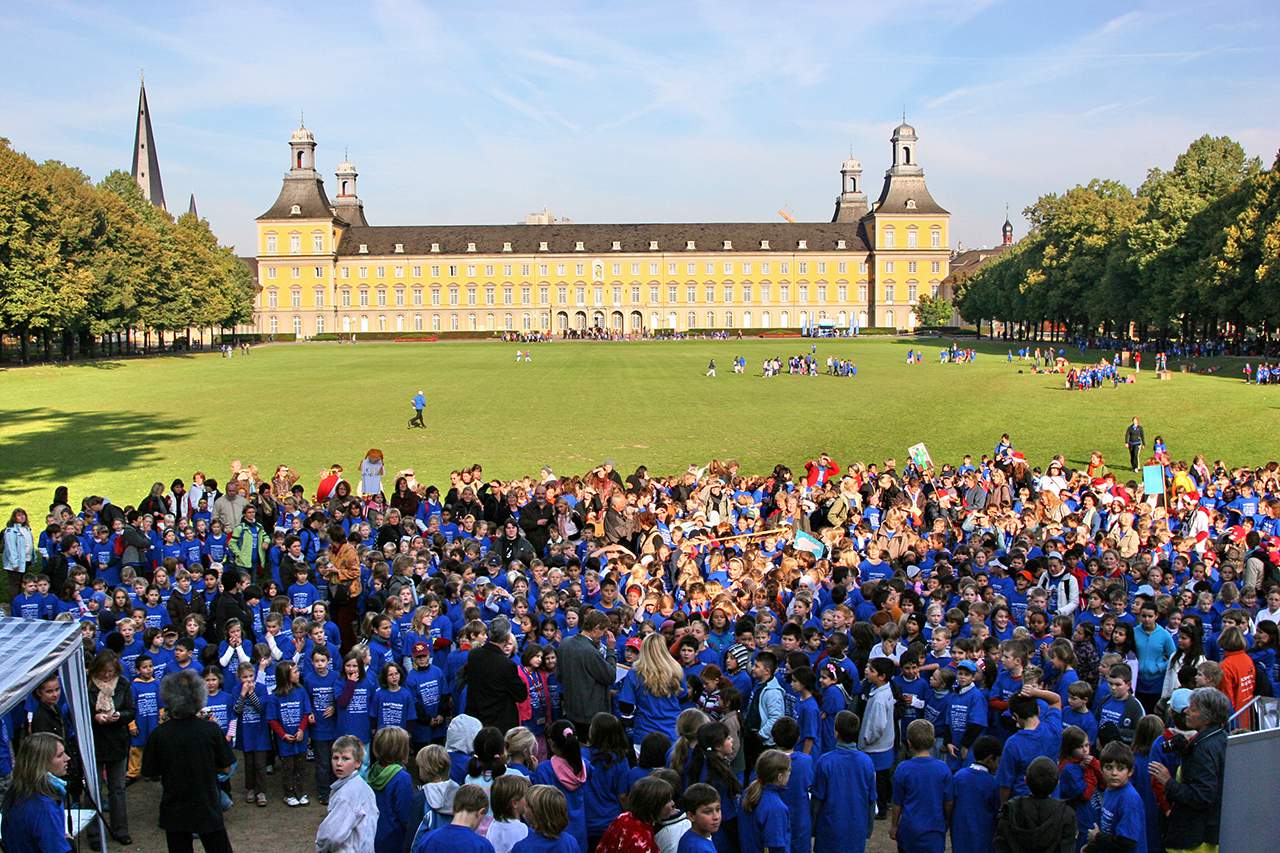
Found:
813,745 -> 876,853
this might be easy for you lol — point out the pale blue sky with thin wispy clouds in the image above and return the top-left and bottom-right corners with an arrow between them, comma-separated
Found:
0,0 -> 1280,248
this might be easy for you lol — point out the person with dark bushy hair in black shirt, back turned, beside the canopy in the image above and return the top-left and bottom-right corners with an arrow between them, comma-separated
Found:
142,670 -> 236,853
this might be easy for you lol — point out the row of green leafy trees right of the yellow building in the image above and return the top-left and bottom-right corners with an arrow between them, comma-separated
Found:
956,134 -> 1280,345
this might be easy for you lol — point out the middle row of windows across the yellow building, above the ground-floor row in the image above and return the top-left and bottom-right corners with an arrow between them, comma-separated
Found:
264,282 -> 938,309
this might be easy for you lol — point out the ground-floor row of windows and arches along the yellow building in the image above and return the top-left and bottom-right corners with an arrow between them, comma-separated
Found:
266,303 -> 893,337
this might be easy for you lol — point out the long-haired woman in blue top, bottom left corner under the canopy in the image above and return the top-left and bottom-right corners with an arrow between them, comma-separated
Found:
0,731 -> 72,853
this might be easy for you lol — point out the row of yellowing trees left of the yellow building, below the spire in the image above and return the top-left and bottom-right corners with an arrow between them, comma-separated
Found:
0,138 -> 255,361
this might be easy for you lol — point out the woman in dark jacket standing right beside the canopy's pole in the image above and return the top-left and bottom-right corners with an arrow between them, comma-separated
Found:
88,649 -> 136,844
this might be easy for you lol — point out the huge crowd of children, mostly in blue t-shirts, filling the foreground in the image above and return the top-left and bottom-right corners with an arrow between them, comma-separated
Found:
0,437 -> 1280,853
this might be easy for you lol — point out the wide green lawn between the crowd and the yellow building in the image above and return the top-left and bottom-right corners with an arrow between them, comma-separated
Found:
0,338 -> 1280,514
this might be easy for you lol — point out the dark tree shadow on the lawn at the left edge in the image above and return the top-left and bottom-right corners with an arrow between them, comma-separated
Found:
0,409 -> 188,499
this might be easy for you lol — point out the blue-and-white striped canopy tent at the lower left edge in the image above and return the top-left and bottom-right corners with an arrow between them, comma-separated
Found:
0,617 -> 106,849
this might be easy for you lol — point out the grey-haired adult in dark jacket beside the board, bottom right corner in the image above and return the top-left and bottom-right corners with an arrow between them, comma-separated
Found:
1148,688 -> 1231,852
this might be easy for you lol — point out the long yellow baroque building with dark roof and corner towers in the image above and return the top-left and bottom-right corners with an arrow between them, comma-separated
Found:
255,123 -> 951,338
